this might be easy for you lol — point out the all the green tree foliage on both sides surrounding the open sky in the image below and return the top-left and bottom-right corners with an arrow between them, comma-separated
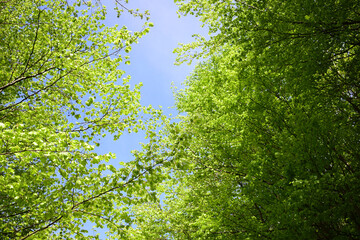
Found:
0,0 -> 360,239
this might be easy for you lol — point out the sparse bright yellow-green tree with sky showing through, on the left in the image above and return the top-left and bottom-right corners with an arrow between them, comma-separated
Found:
0,0 -> 158,239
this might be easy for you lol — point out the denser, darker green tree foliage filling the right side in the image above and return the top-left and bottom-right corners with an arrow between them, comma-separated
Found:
128,0 -> 360,239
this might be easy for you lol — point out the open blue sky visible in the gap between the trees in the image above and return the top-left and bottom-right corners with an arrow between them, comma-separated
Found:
97,0 -> 205,163
